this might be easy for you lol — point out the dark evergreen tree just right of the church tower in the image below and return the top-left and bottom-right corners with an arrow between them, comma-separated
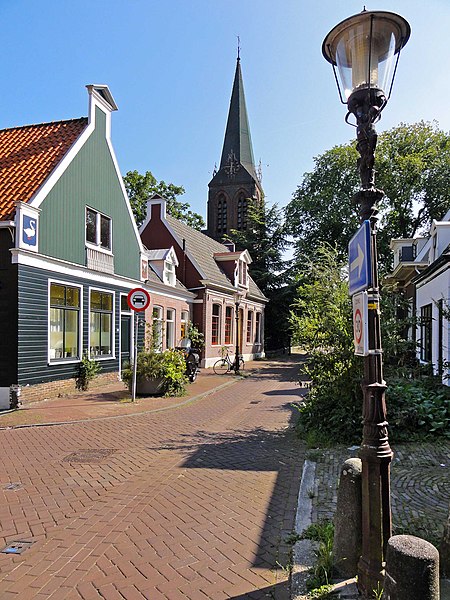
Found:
227,198 -> 293,349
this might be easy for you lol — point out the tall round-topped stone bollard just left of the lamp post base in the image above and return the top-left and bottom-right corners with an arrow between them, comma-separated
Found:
333,458 -> 362,578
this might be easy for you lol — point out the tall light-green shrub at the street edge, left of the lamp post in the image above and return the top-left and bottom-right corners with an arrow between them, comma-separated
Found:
290,245 -> 362,442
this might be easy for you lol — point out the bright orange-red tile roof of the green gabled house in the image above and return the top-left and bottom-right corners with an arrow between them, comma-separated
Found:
0,117 -> 88,220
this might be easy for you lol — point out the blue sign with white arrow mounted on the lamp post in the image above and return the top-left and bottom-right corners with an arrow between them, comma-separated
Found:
348,221 -> 372,296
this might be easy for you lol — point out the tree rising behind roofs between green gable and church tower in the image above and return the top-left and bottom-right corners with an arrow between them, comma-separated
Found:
123,171 -> 205,230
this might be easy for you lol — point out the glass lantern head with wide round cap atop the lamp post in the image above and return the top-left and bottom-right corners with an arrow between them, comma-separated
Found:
322,10 -> 411,101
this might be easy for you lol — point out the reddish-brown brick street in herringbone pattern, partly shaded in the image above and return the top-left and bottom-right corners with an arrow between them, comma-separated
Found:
0,361 -> 304,600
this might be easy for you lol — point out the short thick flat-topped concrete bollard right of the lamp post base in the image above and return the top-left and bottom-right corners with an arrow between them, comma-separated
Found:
383,535 -> 439,600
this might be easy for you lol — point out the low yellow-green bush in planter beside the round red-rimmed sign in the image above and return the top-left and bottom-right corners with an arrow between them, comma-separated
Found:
122,349 -> 187,396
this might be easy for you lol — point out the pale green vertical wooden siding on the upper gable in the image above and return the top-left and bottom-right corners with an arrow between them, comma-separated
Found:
39,108 -> 140,280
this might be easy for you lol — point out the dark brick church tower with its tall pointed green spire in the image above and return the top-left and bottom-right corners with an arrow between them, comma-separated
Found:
207,55 -> 263,241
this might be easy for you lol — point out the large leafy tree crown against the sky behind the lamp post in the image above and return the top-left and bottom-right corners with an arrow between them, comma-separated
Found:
286,121 -> 450,270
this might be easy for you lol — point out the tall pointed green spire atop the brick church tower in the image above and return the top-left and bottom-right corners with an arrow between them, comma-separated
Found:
219,56 -> 257,179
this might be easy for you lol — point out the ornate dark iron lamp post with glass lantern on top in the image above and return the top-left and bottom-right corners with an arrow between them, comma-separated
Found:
322,9 -> 411,597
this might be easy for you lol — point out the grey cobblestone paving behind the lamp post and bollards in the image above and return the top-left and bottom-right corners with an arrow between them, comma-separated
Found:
308,440 -> 450,545
